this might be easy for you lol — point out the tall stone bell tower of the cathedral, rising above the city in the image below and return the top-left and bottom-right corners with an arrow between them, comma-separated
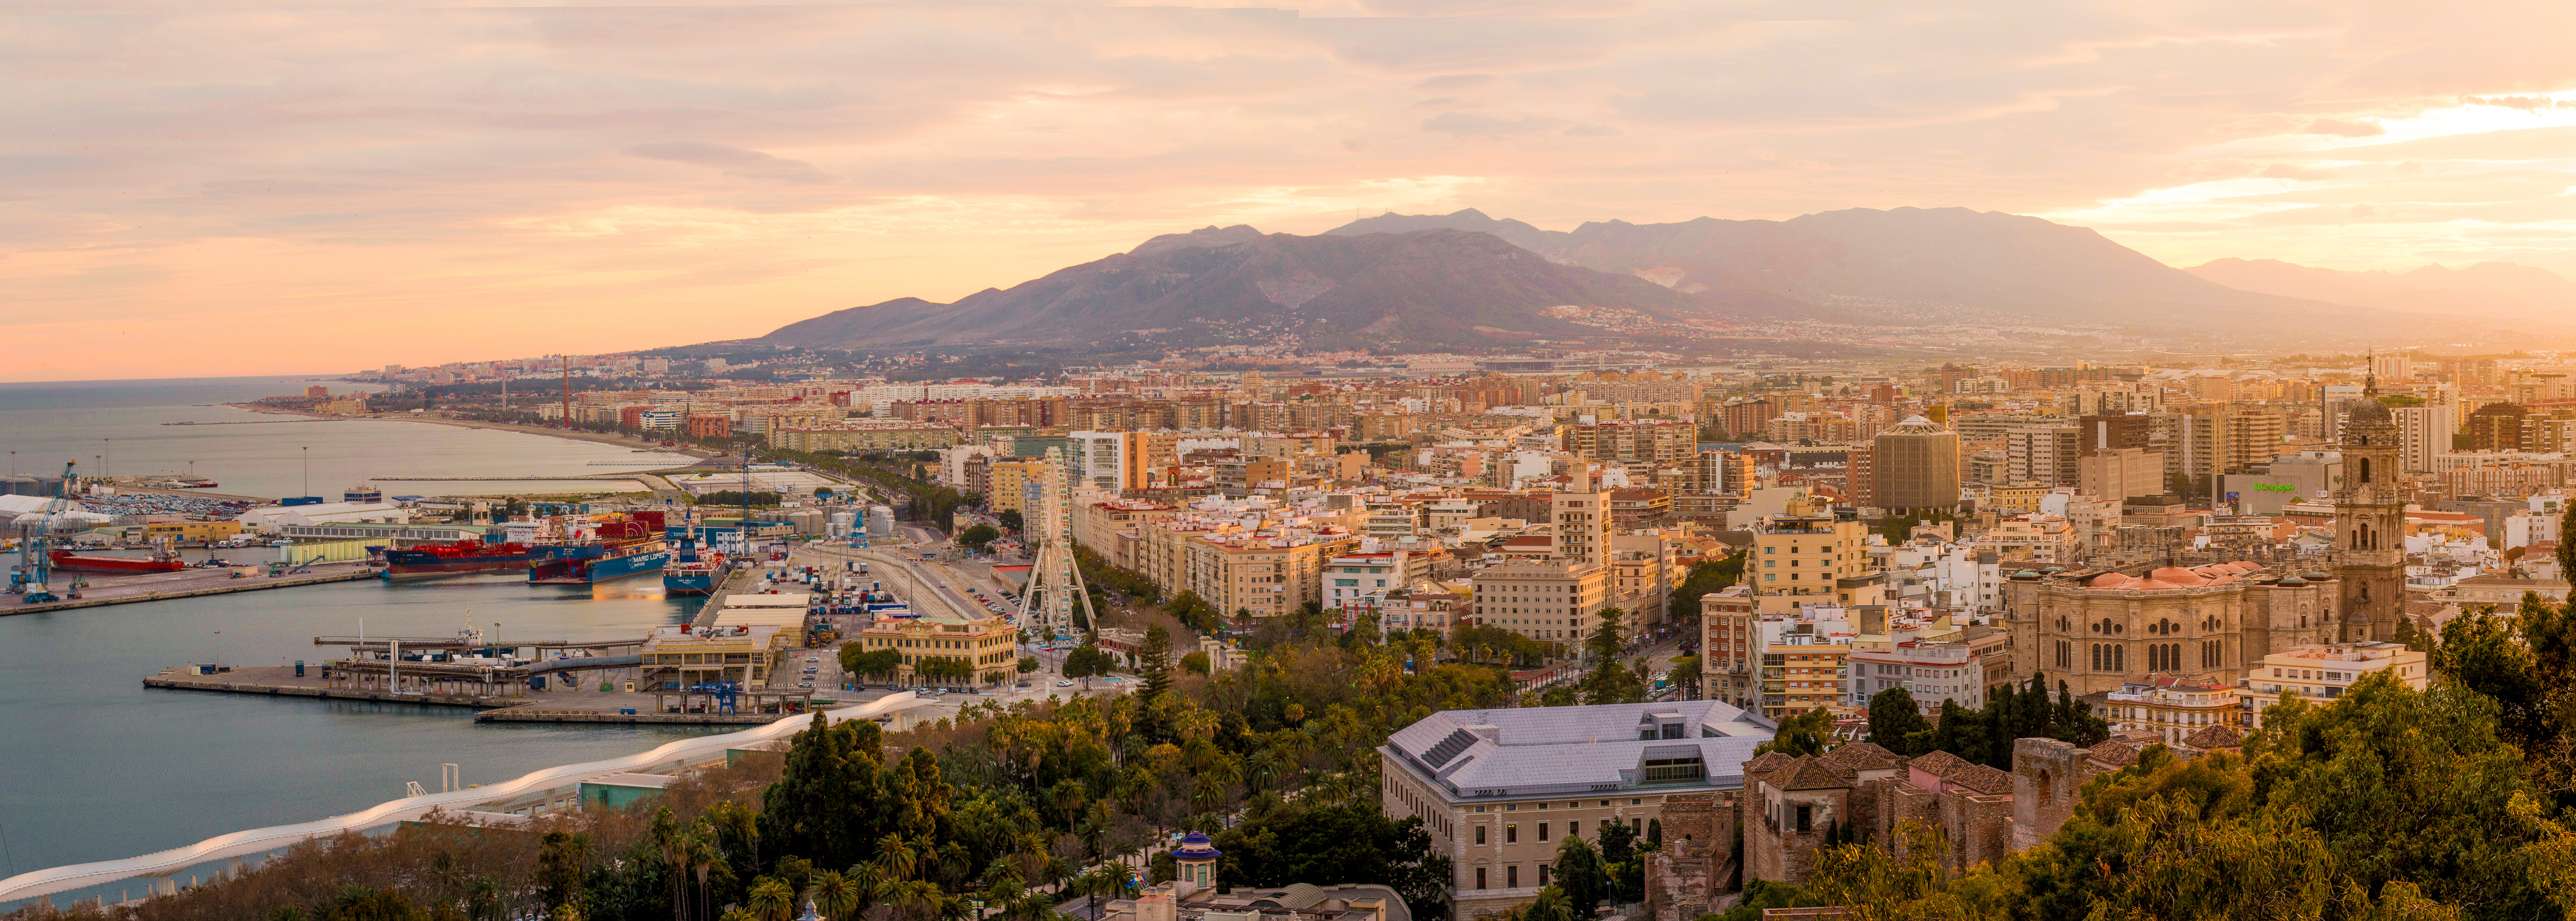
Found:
2334,377 -> 2406,640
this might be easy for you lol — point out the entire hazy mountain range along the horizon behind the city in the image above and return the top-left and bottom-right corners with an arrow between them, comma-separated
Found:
762,209 -> 2576,348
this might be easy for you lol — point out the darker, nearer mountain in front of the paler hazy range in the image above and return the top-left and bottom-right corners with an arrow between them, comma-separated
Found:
765,227 -> 1705,348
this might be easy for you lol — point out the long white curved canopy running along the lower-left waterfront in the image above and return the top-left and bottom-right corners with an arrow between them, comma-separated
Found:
0,691 -> 912,903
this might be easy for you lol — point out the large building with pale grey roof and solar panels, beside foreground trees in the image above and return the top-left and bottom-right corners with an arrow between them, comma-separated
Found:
1378,699 -> 1775,916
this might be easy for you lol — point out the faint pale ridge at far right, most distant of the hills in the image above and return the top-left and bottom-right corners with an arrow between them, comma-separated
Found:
2187,258 -> 2576,322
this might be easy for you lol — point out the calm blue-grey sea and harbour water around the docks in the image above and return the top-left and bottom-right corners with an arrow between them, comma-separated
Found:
0,377 -> 711,911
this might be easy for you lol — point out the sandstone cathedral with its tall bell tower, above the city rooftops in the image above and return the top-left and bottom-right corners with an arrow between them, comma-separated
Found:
1986,387 -> 2406,694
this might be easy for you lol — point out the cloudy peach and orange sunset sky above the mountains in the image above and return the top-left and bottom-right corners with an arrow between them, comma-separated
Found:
0,0 -> 2576,379
